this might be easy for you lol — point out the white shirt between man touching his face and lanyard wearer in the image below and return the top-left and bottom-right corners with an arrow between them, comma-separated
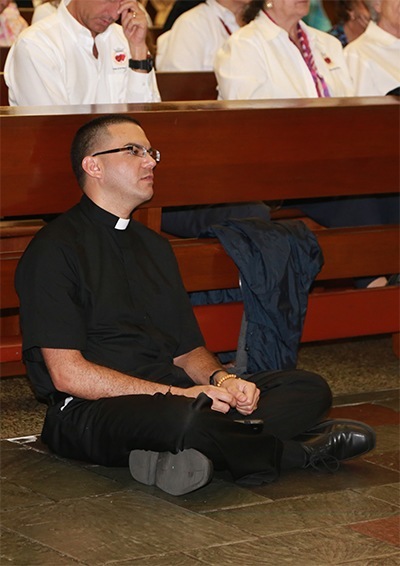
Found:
156,0 -> 239,71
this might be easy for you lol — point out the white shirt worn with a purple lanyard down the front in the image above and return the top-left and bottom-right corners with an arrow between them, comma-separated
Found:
215,12 -> 353,100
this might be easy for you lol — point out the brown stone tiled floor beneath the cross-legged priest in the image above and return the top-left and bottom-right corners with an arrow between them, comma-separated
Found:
0,340 -> 400,566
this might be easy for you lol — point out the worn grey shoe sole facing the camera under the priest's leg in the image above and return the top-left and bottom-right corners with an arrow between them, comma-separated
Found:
129,449 -> 213,495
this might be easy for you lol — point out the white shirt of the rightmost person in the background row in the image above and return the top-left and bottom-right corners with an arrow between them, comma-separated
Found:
344,22 -> 400,96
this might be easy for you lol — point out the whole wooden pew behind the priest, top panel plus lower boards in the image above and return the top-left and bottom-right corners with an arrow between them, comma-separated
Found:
0,97 -> 399,374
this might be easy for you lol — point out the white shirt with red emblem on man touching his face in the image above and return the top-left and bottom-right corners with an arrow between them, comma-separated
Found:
4,3 -> 160,106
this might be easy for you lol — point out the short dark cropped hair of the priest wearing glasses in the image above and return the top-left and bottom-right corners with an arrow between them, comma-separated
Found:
70,114 -> 140,188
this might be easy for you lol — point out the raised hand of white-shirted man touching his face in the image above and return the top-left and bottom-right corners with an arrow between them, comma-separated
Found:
119,0 -> 148,60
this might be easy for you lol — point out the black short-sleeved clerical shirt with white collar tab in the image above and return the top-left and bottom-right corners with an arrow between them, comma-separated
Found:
16,196 -> 204,404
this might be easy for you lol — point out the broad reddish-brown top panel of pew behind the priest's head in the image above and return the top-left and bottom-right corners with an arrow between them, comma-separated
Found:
0,97 -> 399,222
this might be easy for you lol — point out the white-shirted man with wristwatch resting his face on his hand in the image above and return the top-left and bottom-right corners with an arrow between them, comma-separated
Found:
4,0 -> 160,106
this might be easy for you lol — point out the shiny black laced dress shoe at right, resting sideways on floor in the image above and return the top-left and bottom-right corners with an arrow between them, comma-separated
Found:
302,421 -> 376,471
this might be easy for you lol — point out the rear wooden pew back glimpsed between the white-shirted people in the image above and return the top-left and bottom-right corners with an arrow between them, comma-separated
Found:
0,71 -> 218,106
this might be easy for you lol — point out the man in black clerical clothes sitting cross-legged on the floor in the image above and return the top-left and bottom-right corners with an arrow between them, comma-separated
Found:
16,115 -> 375,495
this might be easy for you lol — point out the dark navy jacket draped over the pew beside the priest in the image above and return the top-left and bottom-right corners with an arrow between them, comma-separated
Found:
203,218 -> 323,373
